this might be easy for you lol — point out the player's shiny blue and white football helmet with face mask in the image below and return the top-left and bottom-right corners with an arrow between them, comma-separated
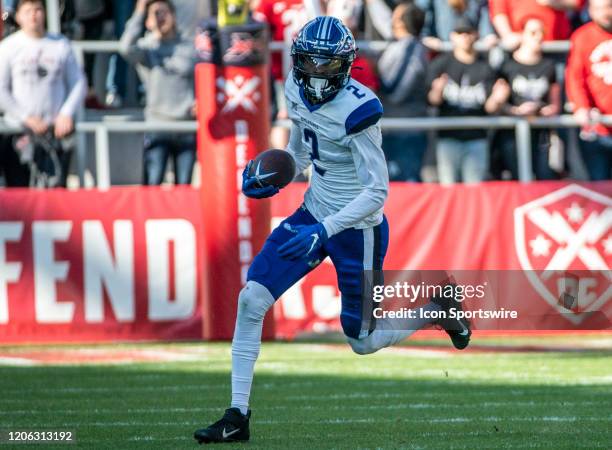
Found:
291,16 -> 357,103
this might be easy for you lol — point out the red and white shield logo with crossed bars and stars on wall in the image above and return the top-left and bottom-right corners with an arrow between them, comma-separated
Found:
514,184 -> 612,325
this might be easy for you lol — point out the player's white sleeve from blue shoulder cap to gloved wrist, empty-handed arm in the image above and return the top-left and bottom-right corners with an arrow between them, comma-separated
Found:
323,125 -> 389,237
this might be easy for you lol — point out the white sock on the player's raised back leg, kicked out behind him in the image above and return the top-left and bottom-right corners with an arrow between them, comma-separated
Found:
349,302 -> 440,355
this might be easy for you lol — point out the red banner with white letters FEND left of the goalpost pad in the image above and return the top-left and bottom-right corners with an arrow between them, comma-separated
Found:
0,188 -> 204,342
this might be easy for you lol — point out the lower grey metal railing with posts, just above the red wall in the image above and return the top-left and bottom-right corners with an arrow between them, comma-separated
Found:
0,115 -> 612,189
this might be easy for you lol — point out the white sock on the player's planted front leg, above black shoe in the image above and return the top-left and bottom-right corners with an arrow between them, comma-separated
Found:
231,281 -> 274,414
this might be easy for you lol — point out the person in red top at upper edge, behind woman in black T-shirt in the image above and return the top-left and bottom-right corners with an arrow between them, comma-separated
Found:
489,0 -> 586,50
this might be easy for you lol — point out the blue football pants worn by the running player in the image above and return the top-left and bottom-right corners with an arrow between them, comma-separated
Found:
247,206 -> 389,339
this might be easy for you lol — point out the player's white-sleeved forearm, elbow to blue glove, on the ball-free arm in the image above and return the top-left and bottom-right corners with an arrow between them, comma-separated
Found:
323,188 -> 387,237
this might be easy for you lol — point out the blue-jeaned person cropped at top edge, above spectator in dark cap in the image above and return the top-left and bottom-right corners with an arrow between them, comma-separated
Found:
416,0 -> 497,50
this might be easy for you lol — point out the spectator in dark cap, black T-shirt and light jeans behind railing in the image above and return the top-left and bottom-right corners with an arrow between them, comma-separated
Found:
428,18 -> 510,184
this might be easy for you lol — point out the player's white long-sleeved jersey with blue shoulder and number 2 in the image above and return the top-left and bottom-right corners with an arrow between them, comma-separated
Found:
285,76 -> 389,237
